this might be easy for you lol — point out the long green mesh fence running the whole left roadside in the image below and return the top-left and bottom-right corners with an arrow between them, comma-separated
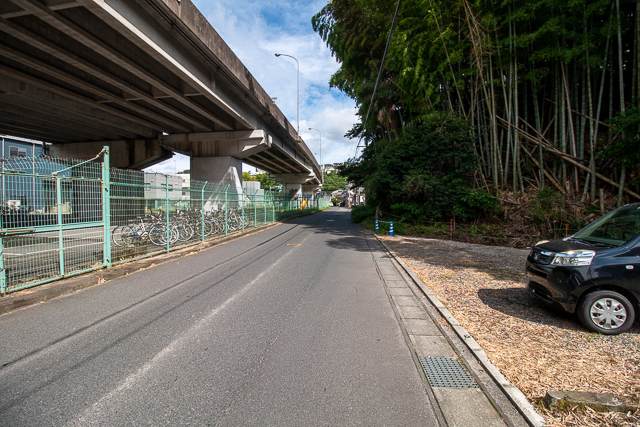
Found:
0,148 -> 330,294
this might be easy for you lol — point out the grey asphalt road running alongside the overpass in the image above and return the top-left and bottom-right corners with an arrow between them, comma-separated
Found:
0,208 -> 437,426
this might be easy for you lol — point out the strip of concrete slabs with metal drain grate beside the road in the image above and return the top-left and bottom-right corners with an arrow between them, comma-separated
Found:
365,232 -> 538,427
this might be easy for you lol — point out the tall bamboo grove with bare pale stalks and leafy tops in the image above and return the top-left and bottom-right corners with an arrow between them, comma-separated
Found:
312,0 -> 640,213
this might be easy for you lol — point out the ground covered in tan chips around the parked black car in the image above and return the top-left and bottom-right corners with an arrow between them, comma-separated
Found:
381,236 -> 640,426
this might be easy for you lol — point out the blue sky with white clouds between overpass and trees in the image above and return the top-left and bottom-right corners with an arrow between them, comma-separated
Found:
146,0 -> 357,173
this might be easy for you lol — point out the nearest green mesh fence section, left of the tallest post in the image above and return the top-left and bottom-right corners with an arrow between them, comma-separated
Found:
0,152 -> 107,293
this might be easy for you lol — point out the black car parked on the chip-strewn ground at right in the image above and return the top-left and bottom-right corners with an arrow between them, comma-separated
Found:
526,203 -> 640,335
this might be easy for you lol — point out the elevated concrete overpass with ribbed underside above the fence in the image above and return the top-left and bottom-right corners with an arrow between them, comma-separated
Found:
0,0 -> 322,194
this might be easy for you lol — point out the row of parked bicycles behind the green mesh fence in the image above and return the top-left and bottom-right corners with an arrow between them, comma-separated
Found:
111,208 -> 254,247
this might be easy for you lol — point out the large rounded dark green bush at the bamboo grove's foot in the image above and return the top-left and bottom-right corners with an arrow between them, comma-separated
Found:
340,113 -> 498,221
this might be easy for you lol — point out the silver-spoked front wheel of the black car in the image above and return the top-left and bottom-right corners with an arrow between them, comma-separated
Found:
578,291 -> 635,335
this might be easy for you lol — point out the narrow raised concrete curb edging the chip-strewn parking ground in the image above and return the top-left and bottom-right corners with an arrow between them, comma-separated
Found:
374,233 -> 544,427
